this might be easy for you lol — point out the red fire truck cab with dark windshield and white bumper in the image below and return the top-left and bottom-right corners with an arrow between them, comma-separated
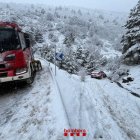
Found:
0,22 -> 34,83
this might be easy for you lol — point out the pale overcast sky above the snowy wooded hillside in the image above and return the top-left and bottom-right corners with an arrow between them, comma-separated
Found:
0,0 -> 138,12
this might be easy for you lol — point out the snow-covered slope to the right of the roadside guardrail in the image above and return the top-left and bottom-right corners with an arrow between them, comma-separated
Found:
51,62 -> 140,140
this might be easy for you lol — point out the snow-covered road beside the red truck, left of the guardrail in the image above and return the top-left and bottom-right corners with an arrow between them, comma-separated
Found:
0,61 -> 69,140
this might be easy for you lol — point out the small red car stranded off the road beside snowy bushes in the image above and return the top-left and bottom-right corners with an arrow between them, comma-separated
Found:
91,71 -> 106,79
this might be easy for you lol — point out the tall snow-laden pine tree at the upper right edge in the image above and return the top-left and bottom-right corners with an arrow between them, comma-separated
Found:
121,0 -> 140,63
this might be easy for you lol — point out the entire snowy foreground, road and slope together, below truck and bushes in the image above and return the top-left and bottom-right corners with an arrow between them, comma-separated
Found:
0,60 -> 140,140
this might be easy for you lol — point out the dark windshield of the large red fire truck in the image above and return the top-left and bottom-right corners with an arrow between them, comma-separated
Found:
0,28 -> 20,53
